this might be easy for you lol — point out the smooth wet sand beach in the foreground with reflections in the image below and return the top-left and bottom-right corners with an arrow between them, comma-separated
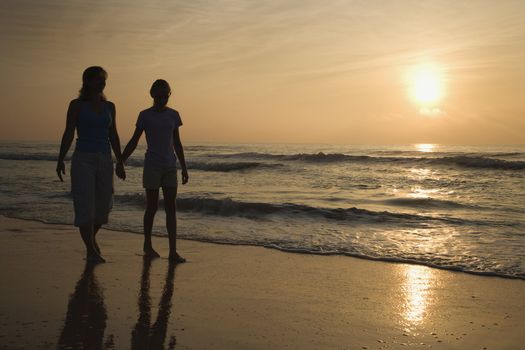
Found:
0,217 -> 525,350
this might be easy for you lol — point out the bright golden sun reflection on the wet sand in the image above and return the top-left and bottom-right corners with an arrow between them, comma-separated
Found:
402,265 -> 436,328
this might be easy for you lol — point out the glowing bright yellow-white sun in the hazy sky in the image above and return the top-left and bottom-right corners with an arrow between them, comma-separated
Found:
408,64 -> 443,107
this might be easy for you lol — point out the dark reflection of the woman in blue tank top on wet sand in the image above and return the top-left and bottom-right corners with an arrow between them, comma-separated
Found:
58,262 -> 114,349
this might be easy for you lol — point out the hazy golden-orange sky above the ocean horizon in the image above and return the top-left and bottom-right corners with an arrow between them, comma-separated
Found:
0,0 -> 525,144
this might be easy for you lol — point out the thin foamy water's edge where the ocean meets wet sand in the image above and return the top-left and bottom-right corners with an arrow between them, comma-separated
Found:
0,214 -> 525,281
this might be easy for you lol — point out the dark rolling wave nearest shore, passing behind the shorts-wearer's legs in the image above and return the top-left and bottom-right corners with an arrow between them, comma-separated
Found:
115,193 -> 463,224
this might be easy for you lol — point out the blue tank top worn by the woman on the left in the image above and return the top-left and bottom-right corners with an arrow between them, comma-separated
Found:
75,101 -> 113,154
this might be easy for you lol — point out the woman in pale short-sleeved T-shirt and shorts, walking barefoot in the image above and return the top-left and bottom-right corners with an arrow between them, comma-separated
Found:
122,79 -> 188,263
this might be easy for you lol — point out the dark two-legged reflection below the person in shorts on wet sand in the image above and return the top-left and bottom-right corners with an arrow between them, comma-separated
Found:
131,257 -> 176,349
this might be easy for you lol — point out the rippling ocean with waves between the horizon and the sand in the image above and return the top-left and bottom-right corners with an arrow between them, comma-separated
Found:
0,142 -> 525,279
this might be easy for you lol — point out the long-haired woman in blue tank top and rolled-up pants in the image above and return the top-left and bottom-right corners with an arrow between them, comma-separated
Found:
56,67 -> 126,262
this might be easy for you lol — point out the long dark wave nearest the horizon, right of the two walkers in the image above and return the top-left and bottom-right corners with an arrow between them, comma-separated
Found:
209,152 -> 525,170
